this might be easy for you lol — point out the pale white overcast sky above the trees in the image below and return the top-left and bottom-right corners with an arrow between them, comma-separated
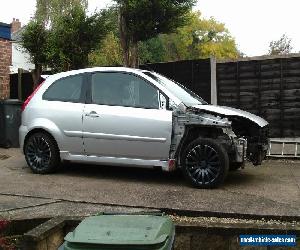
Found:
0,0 -> 300,56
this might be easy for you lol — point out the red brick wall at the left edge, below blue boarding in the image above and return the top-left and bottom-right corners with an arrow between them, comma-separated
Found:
0,38 -> 12,99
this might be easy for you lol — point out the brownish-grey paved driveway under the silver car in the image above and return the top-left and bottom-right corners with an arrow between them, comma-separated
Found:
0,149 -> 300,219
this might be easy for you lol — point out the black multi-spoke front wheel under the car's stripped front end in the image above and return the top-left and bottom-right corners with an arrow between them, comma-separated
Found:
181,138 -> 229,188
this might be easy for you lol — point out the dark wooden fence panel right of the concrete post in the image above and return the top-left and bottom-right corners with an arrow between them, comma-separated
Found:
217,57 -> 300,137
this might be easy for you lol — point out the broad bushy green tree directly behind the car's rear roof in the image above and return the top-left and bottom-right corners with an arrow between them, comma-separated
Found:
47,5 -> 110,71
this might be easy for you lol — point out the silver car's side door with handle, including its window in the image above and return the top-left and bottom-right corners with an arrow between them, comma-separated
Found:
83,72 -> 172,160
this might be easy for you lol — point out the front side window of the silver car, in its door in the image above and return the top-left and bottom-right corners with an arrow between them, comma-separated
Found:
92,72 -> 159,109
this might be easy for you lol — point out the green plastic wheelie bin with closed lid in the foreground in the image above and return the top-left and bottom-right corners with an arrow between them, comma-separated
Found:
59,215 -> 175,250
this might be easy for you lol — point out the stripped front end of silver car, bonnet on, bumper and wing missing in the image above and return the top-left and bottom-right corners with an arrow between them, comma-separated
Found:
170,105 -> 268,168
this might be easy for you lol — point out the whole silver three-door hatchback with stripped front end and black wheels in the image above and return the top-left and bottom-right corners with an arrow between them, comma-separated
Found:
20,67 -> 268,188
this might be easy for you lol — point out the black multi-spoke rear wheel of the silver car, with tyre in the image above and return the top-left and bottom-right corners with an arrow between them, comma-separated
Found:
24,133 -> 60,174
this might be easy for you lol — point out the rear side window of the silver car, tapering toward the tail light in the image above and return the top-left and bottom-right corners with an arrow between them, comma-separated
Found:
43,75 -> 83,102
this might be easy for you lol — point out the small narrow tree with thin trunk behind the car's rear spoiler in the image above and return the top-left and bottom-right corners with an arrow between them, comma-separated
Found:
22,20 -> 49,88
